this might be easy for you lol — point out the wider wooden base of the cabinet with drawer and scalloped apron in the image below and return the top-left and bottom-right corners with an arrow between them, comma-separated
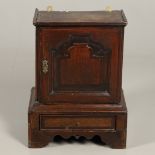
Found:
28,88 -> 127,149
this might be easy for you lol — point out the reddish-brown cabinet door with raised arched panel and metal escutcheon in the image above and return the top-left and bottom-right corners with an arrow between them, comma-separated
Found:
37,27 -> 122,103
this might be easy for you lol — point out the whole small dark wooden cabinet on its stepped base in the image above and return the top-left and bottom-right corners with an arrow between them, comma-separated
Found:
29,9 -> 127,148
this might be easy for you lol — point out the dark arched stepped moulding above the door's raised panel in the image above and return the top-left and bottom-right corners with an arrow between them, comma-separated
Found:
51,34 -> 111,57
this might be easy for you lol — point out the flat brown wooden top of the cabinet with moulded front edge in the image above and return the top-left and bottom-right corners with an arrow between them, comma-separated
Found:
33,9 -> 127,26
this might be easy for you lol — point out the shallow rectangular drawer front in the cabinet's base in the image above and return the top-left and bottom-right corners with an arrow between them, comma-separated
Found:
40,115 -> 115,130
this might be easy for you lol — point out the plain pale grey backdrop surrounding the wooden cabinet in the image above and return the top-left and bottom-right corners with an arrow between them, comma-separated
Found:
0,0 -> 155,155
